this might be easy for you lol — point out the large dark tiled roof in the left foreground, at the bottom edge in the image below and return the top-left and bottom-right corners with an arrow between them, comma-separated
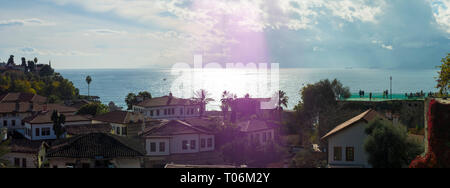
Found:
47,133 -> 144,159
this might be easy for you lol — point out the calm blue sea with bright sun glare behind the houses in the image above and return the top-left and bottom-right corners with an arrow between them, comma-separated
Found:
57,69 -> 437,109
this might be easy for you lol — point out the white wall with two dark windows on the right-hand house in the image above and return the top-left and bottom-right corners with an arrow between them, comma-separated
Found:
327,122 -> 371,168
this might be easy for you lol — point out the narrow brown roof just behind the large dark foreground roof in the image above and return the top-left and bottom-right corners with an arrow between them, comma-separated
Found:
64,123 -> 111,135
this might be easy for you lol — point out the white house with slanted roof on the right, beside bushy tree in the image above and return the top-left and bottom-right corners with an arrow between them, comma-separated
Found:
322,110 -> 384,168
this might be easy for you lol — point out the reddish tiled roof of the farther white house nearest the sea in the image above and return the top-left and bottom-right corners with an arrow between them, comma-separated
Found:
136,96 -> 195,107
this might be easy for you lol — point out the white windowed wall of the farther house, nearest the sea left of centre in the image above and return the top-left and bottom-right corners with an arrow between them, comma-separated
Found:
133,105 -> 200,120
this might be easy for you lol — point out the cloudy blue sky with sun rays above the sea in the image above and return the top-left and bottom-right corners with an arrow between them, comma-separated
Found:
0,0 -> 450,69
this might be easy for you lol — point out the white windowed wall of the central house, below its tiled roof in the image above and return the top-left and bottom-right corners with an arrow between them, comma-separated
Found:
145,134 -> 215,156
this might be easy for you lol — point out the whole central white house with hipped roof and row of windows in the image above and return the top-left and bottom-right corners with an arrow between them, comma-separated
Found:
141,120 -> 215,156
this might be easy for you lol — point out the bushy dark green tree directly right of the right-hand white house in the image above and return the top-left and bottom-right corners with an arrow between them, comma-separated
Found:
364,120 -> 424,168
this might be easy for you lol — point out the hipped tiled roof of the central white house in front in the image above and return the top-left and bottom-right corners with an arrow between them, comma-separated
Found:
141,120 -> 212,137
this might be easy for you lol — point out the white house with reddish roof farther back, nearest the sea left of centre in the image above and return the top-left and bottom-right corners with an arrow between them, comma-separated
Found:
133,94 -> 200,120
